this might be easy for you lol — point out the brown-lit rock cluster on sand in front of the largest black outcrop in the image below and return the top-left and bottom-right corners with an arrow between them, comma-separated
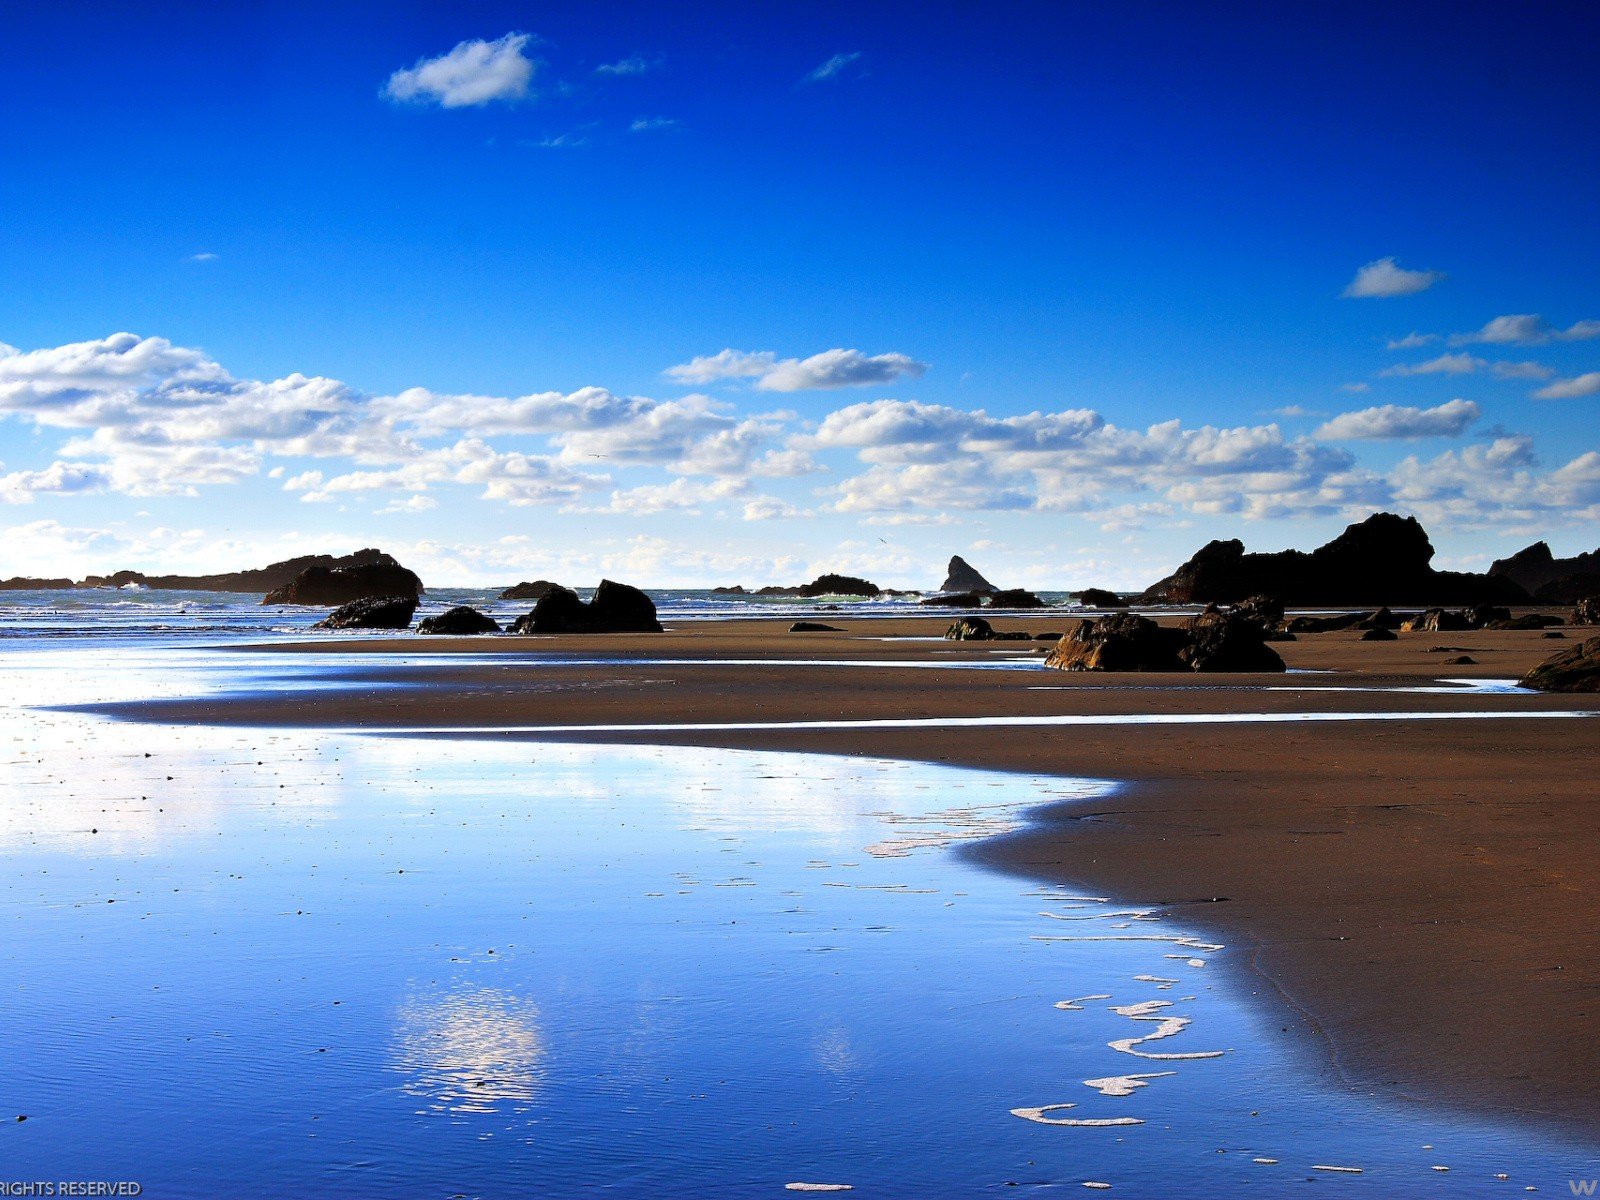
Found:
1045,608 -> 1285,672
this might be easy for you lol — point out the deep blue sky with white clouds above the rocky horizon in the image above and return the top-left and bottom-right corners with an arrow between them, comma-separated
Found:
0,3 -> 1600,587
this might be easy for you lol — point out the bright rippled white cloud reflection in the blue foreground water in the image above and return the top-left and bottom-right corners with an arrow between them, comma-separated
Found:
392,987 -> 544,1112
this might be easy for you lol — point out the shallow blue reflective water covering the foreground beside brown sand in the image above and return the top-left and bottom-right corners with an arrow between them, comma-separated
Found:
0,646 -> 1594,1197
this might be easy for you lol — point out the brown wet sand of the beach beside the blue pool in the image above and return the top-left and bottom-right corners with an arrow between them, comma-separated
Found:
106,616 -> 1600,1141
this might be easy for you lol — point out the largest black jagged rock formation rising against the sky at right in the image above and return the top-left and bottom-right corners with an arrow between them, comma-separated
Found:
1141,512 -> 1526,605
